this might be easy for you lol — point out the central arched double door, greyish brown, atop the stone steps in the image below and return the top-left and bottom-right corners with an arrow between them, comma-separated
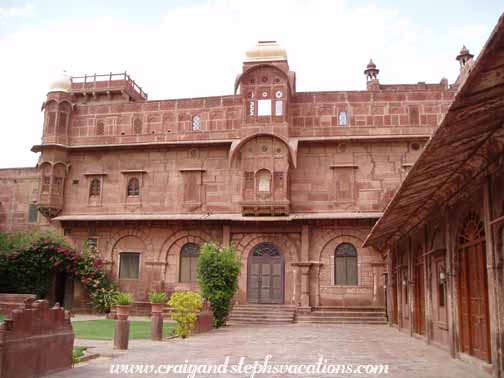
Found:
247,243 -> 285,304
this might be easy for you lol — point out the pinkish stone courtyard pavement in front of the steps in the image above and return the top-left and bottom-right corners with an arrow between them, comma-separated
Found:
50,324 -> 486,378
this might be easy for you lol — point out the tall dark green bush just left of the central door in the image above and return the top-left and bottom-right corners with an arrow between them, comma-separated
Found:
198,244 -> 241,328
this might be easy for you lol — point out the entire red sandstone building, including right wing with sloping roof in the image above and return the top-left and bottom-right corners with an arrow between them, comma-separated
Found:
0,20 -> 504,375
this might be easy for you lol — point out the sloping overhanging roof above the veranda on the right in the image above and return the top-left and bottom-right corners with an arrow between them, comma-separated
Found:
364,14 -> 504,250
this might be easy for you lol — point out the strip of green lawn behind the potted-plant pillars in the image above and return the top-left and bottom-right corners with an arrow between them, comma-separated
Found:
72,319 -> 175,340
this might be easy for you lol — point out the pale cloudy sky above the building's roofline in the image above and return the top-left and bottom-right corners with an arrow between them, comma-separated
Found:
0,0 -> 504,167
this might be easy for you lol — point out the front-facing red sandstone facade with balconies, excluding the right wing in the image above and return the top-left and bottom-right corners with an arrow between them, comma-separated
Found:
0,42 -> 455,314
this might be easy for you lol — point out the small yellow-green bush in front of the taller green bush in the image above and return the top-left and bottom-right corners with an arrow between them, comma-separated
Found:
168,291 -> 202,339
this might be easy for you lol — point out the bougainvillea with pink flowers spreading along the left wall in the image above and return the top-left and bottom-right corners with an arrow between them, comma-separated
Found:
0,232 -> 117,311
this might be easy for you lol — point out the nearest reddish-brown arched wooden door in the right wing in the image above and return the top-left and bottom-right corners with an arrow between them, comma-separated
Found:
457,211 -> 490,362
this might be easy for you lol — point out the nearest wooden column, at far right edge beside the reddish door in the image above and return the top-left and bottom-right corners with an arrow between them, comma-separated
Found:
483,178 -> 503,377
